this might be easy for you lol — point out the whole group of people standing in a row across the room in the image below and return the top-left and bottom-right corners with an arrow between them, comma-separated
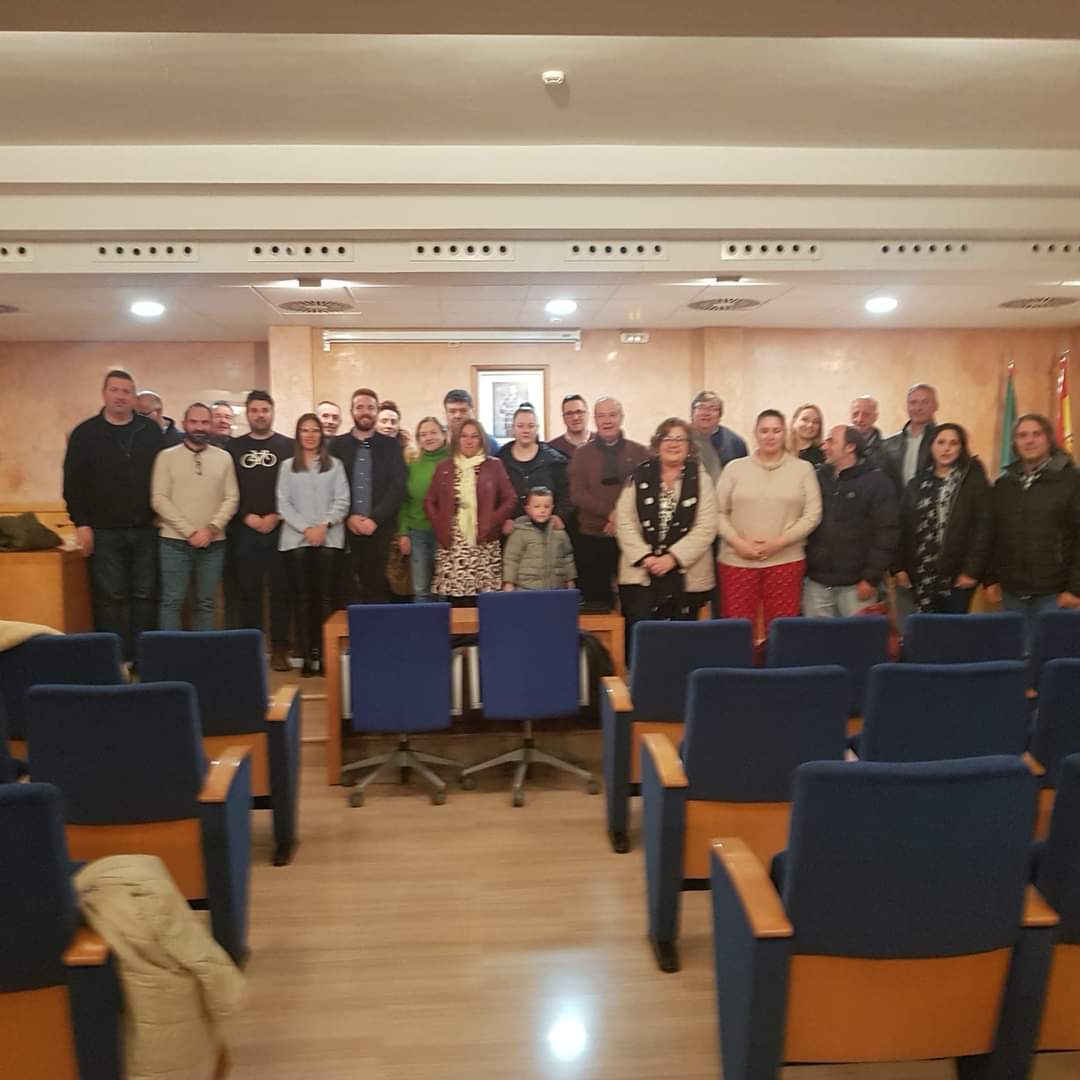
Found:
64,369 -> 1080,674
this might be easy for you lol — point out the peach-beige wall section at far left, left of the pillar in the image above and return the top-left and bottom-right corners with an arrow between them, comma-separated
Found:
0,341 -> 268,502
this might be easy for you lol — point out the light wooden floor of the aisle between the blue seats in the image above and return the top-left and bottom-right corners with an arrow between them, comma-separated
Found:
227,679 -> 1080,1080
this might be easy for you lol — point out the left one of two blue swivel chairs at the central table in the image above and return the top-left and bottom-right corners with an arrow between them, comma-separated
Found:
343,604 -> 462,807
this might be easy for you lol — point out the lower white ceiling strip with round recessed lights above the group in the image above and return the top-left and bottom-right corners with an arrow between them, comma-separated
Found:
0,271 -> 1080,341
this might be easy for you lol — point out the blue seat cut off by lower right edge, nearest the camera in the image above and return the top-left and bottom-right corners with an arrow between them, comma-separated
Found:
1035,754 -> 1080,1050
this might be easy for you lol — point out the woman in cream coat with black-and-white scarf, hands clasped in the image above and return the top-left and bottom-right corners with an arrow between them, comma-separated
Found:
615,417 -> 716,653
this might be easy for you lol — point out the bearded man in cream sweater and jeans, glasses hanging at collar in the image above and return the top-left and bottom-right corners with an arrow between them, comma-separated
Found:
150,402 -> 240,630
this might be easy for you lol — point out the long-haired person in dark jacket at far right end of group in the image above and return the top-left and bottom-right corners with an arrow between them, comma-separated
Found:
986,413 -> 1080,648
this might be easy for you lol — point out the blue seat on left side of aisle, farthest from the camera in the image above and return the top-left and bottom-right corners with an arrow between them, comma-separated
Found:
138,630 -> 301,866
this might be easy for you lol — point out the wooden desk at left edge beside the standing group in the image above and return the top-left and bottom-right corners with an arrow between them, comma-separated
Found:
0,548 -> 94,634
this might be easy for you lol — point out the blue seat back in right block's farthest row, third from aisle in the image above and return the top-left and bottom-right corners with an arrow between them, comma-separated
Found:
901,611 -> 1024,664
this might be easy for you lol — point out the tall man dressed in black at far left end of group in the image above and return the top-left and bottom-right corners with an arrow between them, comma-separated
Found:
64,368 -> 165,660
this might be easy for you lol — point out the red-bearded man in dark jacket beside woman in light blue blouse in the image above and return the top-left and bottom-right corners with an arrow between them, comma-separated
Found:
330,389 -> 406,604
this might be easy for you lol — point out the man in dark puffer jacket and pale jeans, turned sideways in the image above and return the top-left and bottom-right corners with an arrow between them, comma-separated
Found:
802,424 -> 900,618
